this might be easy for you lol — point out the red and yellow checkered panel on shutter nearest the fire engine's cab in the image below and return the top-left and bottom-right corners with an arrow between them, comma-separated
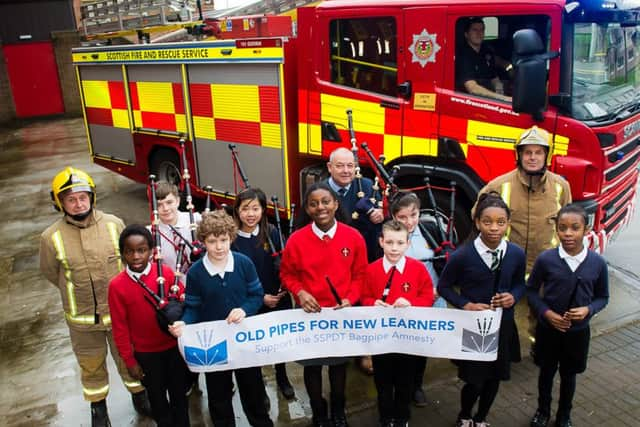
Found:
189,83 -> 282,148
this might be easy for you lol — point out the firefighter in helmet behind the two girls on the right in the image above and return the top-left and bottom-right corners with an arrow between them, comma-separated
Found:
474,126 -> 571,352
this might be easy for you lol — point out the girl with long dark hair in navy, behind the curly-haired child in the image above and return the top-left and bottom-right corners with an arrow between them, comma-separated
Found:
231,188 -> 295,399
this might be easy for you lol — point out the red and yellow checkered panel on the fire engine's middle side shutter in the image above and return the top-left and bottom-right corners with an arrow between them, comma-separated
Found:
129,81 -> 187,133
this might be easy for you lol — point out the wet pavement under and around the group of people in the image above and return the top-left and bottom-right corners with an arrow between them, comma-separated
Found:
0,119 -> 640,427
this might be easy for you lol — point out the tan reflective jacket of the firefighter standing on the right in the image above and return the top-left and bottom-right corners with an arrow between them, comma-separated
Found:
473,169 -> 571,274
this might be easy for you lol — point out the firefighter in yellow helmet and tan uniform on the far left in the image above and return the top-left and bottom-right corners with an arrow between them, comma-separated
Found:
40,167 -> 150,426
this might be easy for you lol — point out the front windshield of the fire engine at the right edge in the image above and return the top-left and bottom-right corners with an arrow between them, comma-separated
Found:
572,22 -> 640,121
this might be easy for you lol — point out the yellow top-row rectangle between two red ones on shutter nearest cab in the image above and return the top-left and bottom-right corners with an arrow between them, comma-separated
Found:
211,84 -> 260,122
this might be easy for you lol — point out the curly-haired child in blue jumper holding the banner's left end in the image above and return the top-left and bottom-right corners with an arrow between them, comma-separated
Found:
170,210 -> 273,427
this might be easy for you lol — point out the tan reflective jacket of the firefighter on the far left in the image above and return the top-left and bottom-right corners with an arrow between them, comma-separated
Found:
40,209 -> 124,330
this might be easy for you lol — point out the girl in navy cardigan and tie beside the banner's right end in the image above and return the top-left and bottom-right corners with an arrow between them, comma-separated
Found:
438,192 -> 526,427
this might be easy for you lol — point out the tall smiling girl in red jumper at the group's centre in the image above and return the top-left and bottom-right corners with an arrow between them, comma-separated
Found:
280,183 -> 367,427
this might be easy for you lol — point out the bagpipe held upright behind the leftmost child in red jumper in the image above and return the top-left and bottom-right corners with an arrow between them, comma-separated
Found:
136,175 -> 186,334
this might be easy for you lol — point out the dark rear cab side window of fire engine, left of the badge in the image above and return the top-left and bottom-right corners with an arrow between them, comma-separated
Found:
329,17 -> 398,96
